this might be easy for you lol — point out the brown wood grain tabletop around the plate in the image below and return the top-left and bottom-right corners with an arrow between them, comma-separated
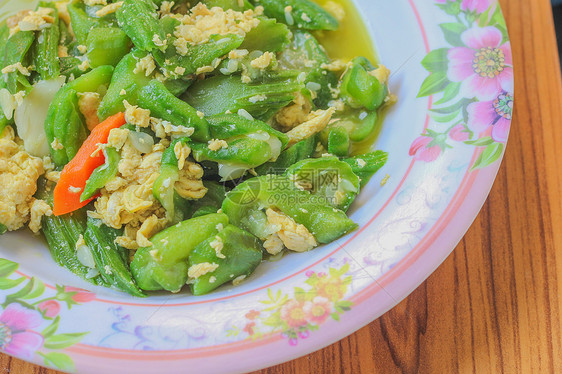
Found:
0,0 -> 562,374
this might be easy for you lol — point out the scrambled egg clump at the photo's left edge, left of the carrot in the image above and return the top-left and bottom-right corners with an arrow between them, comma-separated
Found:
0,127 -> 52,232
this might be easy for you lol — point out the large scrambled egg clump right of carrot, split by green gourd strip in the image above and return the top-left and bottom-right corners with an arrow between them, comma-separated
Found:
95,136 -> 207,250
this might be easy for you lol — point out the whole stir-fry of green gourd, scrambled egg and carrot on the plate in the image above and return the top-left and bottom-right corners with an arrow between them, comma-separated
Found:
0,0 -> 395,296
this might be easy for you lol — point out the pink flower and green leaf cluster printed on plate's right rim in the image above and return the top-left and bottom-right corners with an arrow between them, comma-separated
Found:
409,0 -> 514,169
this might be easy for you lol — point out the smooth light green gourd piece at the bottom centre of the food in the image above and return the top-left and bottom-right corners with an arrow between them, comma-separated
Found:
131,213 -> 228,292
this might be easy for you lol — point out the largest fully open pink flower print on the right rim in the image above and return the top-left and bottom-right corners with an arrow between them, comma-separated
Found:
447,26 -> 513,101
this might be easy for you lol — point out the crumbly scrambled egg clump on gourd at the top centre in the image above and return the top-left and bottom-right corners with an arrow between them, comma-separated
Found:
174,3 -> 260,55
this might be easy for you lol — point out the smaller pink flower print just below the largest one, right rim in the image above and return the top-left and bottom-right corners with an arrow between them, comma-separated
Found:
466,92 -> 513,142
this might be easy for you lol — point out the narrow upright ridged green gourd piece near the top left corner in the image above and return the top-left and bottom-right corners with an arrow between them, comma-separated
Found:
33,1 -> 61,80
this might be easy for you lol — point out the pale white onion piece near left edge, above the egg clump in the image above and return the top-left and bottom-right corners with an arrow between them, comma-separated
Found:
14,77 -> 65,157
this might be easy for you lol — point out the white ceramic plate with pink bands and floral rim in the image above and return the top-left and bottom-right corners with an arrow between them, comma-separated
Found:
0,0 -> 513,373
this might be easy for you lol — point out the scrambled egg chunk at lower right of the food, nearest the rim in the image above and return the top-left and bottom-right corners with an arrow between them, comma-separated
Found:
264,208 -> 318,255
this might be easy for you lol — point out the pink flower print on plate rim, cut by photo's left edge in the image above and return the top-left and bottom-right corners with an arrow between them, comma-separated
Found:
0,303 -> 44,360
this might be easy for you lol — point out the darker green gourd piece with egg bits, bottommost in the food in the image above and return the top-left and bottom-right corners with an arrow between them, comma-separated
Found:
188,225 -> 263,296
